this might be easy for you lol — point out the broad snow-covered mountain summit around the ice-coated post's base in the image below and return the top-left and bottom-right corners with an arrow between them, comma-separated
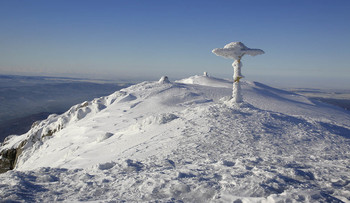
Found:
0,75 -> 350,202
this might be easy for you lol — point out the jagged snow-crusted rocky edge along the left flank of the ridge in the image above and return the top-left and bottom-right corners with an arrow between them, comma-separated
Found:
0,95 -> 123,173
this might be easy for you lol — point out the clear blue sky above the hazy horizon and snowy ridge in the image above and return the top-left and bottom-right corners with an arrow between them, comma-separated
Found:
0,0 -> 350,88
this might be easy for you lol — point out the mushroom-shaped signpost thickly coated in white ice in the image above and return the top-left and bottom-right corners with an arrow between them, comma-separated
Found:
212,42 -> 265,103
